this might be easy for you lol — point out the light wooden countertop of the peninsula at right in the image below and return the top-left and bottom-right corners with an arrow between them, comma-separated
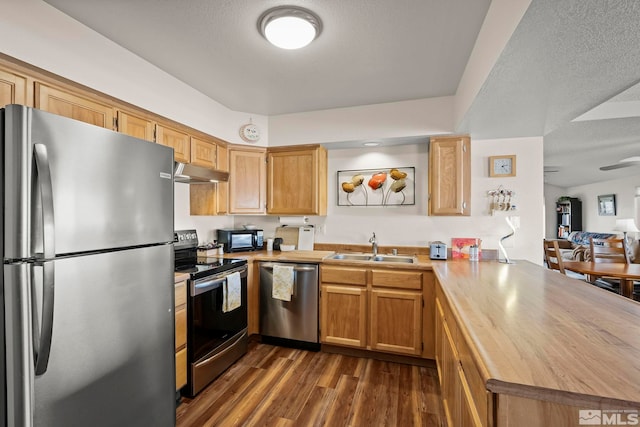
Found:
433,261 -> 640,409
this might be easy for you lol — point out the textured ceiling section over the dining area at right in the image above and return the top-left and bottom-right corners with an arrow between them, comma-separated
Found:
461,0 -> 640,187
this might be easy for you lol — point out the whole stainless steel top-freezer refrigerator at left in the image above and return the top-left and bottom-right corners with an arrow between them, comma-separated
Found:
0,105 -> 176,427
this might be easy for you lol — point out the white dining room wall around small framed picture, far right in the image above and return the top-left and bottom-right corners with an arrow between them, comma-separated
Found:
567,175 -> 640,236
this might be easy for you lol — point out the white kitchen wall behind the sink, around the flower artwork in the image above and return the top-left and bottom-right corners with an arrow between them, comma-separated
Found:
236,138 -> 544,263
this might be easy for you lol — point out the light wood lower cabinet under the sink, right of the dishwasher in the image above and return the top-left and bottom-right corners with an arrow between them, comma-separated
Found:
320,266 -> 433,356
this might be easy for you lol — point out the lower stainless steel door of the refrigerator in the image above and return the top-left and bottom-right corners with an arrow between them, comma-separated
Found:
4,244 -> 175,427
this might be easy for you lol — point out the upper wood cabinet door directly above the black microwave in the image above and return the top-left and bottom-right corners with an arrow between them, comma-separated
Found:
229,149 -> 267,214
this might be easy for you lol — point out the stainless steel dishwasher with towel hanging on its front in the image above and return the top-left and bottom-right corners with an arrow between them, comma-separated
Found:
260,262 -> 320,350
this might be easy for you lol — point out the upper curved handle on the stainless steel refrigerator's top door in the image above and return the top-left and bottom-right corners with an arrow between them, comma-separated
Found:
33,144 -> 56,259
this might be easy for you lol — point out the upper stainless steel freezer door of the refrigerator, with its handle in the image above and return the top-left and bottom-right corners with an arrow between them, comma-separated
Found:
1,105 -> 173,259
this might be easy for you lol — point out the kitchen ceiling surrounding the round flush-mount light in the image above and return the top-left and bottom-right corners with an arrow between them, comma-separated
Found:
41,0 -> 490,115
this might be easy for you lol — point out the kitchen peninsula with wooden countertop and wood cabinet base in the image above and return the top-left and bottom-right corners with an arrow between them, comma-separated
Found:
433,261 -> 640,427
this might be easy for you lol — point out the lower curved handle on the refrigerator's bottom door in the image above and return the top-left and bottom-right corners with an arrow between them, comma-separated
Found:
32,261 -> 55,375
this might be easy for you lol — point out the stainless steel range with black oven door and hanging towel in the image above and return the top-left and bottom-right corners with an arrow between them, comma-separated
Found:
174,230 -> 248,396
